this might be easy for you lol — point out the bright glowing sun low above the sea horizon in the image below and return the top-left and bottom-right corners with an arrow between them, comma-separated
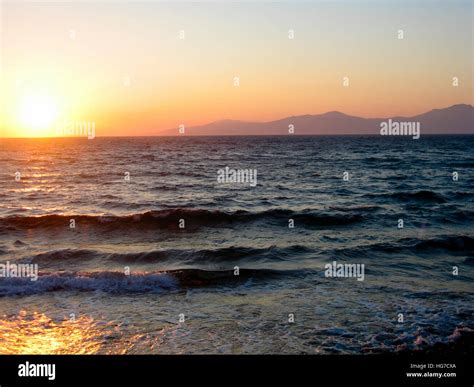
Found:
19,94 -> 58,134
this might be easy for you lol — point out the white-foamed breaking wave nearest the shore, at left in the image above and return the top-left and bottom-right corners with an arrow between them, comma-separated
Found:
0,268 -> 292,296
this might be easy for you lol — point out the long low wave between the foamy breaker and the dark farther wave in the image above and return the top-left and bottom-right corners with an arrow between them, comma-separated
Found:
12,235 -> 474,265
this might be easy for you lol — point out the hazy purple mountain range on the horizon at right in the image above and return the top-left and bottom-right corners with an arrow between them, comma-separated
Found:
160,104 -> 474,136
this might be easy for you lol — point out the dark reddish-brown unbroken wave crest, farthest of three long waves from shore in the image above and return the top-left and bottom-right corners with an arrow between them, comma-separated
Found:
0,208 -> 364,231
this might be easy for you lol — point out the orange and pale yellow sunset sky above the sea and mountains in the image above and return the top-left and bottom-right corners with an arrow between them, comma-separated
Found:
0,1 -> 474,137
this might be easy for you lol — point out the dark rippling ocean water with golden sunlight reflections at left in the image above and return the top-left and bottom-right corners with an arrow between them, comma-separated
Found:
0,136 -> 474,354
